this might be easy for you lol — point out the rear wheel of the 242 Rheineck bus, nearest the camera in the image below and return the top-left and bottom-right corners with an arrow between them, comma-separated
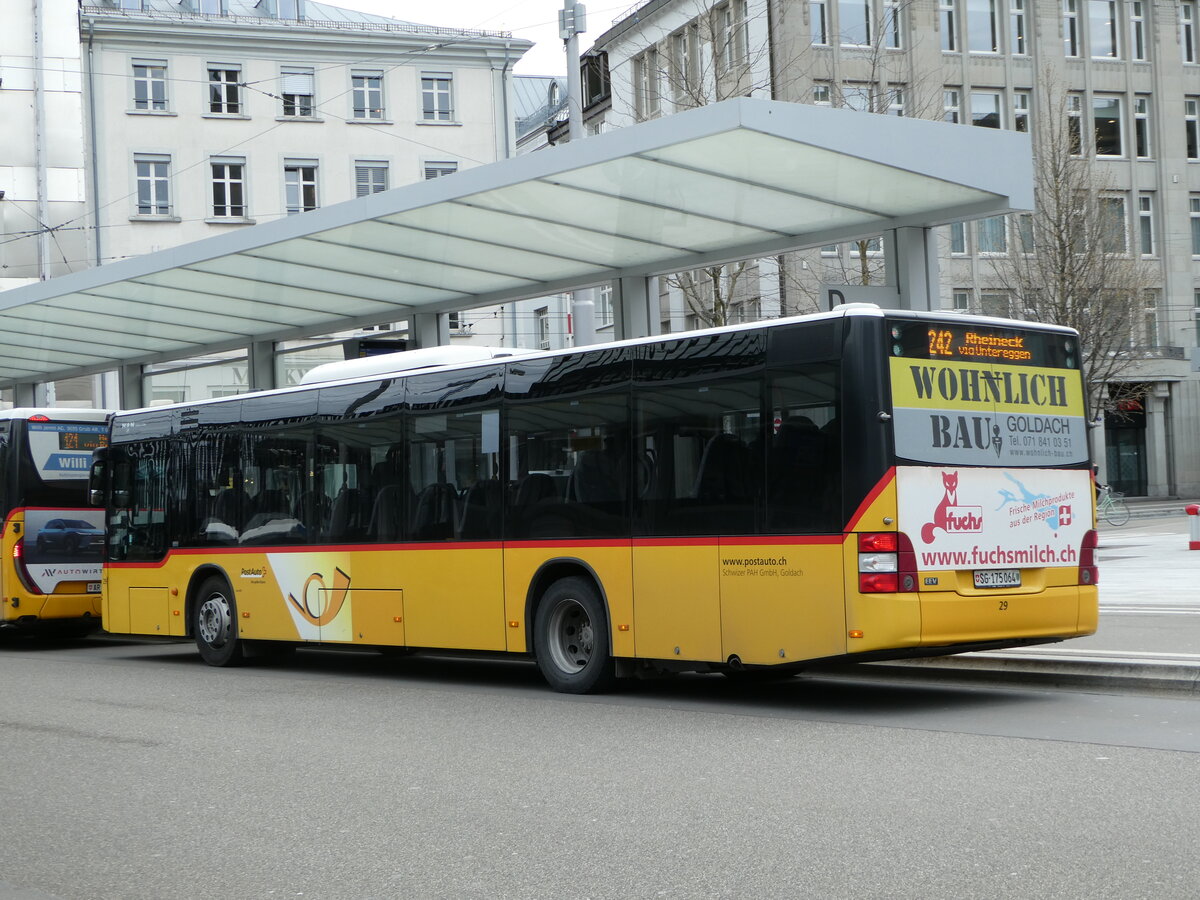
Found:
534,577 -> 616,694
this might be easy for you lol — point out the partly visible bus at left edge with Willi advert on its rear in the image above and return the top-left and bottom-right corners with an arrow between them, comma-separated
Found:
0,409 -> 108,635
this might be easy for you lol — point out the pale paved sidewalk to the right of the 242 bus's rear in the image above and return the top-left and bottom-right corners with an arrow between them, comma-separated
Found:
880,497 -> 1200,692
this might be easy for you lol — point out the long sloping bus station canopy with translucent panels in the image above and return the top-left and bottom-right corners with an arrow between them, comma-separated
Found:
0,98 -> 1033,385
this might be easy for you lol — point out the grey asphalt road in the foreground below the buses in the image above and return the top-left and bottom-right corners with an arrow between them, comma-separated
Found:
0,640 -> 1200,900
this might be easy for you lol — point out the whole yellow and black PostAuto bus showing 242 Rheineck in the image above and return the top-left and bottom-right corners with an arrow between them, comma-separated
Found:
94,305 -> 1097,692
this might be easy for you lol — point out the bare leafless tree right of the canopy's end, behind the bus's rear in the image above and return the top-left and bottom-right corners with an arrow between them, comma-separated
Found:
991,76 -> 1156,418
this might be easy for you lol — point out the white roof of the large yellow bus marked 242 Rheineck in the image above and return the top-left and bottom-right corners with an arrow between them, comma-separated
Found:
105,302 -> 1076,418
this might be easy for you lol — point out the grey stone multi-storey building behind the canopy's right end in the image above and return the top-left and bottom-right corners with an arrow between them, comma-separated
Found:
592,0 -> 1200,497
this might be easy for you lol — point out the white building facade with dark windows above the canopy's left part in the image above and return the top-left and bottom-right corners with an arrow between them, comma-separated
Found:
0,0 -> 530,403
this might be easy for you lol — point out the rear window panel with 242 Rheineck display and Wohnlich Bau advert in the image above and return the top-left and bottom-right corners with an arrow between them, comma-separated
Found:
889,323 -> 1087,467
